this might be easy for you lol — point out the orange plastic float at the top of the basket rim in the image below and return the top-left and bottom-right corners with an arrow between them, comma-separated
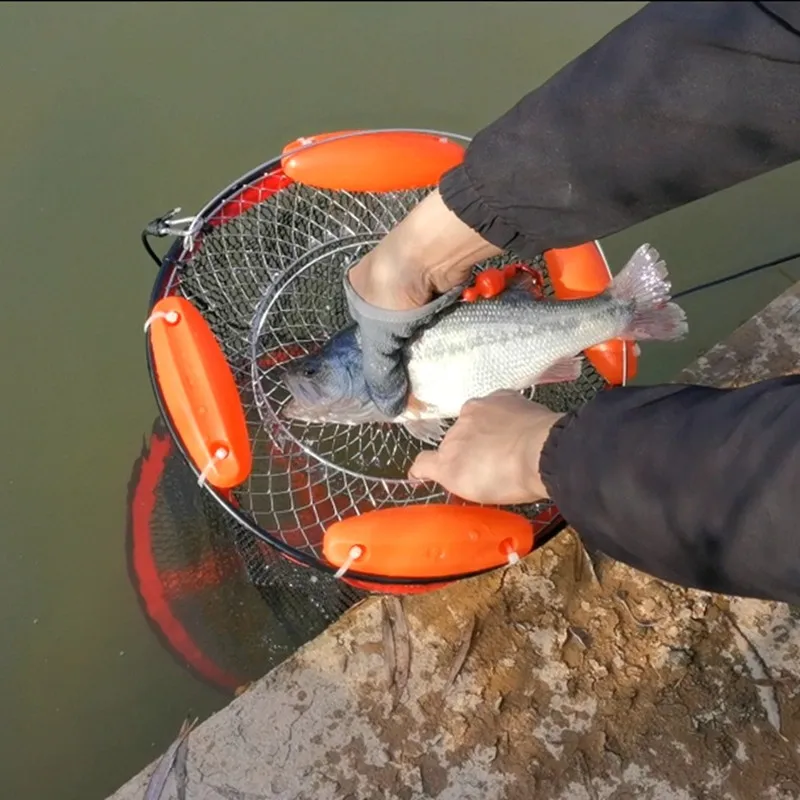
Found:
281,131 -> 464,192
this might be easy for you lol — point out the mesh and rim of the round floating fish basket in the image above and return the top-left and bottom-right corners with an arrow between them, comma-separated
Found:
143,131 -> 607,591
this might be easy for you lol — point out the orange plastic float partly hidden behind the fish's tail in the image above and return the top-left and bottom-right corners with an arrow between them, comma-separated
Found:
543,242 -> 638,386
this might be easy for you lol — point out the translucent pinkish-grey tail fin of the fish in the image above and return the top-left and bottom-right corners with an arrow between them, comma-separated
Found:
608,244 -> 689,342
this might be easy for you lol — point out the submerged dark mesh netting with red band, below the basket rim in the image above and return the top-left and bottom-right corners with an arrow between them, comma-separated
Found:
127,421 -> 364,692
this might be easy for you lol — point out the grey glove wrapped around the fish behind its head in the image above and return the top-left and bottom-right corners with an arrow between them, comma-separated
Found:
344,273 -> 463,419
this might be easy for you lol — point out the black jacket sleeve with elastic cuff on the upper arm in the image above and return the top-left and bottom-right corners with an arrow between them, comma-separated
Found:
440,2 -> 800,258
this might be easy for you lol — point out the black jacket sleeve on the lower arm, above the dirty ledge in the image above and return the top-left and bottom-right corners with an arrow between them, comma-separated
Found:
540,375 -> 800,603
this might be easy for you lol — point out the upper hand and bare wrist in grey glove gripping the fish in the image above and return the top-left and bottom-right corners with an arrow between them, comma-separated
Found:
344,191 -> 502,419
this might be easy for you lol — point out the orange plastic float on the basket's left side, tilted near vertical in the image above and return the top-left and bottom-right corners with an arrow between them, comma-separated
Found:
149,296 -> 252,489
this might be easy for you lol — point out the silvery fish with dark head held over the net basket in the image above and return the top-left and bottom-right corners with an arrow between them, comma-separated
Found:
281,244 -> 688,445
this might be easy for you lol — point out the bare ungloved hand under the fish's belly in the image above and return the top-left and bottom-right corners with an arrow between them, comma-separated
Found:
409,391 -> 563,505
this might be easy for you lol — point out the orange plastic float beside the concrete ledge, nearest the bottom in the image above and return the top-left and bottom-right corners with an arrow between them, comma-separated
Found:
322,504 -> 533,578
